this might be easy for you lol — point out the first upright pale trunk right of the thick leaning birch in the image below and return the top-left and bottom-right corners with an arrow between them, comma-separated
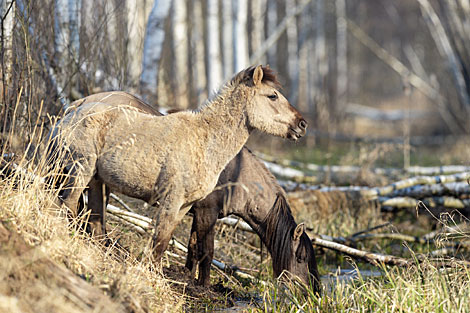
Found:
172,0 -> 189,109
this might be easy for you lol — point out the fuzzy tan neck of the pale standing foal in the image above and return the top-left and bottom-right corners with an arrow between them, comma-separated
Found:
198,98 -> 251,171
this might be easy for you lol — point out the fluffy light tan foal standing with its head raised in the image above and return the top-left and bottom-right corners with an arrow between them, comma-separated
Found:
48,66 -> 307,261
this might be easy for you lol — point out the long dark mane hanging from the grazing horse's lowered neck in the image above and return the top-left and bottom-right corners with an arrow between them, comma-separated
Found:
258,193 -> 316,276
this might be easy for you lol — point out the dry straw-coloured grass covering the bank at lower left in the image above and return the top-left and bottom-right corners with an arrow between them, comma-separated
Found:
0,115 -> 183,312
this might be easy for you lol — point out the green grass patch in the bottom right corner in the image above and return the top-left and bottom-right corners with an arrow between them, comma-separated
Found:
255,262 -> 470,312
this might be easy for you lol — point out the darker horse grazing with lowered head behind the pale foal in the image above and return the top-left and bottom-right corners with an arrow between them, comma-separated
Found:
67,91 -> 319,291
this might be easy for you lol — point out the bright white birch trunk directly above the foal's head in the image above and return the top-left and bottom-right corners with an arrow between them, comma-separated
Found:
232,0 -> 248,72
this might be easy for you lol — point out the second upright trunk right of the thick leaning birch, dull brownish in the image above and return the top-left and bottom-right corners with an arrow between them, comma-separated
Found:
191,0 -> 207,105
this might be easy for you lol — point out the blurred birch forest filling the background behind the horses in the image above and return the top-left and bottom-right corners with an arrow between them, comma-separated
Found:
0,0 -> 470,147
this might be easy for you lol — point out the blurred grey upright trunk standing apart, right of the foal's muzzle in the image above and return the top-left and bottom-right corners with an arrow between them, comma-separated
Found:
336,0 -> 348,112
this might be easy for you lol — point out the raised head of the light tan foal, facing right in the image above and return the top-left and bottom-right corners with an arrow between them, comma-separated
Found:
237,65 -> 307,140
